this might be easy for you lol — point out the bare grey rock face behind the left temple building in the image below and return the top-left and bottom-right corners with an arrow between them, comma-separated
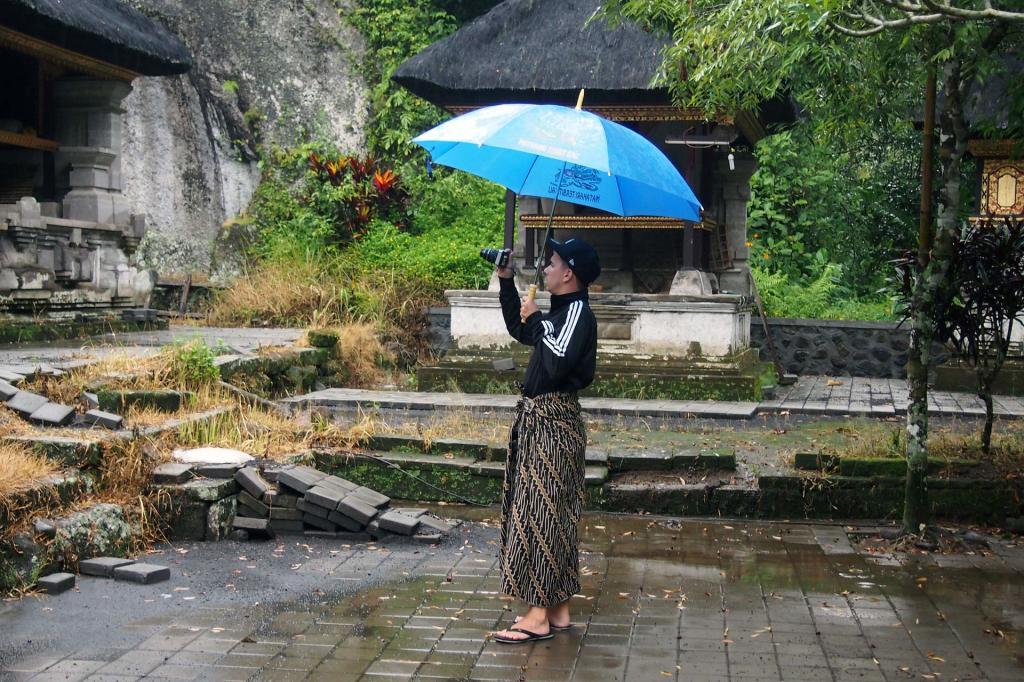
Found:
122,0 -> 367,273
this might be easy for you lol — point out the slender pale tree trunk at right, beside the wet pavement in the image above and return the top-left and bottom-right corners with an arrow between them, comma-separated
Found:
903,57 -> 968,532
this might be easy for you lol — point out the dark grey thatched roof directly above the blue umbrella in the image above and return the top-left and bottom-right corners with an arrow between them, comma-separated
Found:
393,0 -> 669,105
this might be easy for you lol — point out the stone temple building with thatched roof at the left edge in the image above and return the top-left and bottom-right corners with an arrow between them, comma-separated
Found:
0,0 -> 191,340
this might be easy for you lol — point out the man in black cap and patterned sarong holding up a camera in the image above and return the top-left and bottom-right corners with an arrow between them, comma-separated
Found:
494,239 -> 601,644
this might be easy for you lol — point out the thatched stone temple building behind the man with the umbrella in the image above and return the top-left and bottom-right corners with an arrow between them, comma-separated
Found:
393,0 -> 794,398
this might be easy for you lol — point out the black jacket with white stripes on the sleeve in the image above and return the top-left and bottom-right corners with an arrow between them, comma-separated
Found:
499,278 -> 597,397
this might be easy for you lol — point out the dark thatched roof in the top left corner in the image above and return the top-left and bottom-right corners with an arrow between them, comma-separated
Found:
0,0 -> 191,76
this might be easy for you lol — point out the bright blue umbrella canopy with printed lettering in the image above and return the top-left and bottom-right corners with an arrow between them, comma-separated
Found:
413,104 -> 700,222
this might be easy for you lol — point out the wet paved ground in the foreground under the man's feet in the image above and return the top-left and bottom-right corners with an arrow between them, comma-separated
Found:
0,507 -> 1024,682
